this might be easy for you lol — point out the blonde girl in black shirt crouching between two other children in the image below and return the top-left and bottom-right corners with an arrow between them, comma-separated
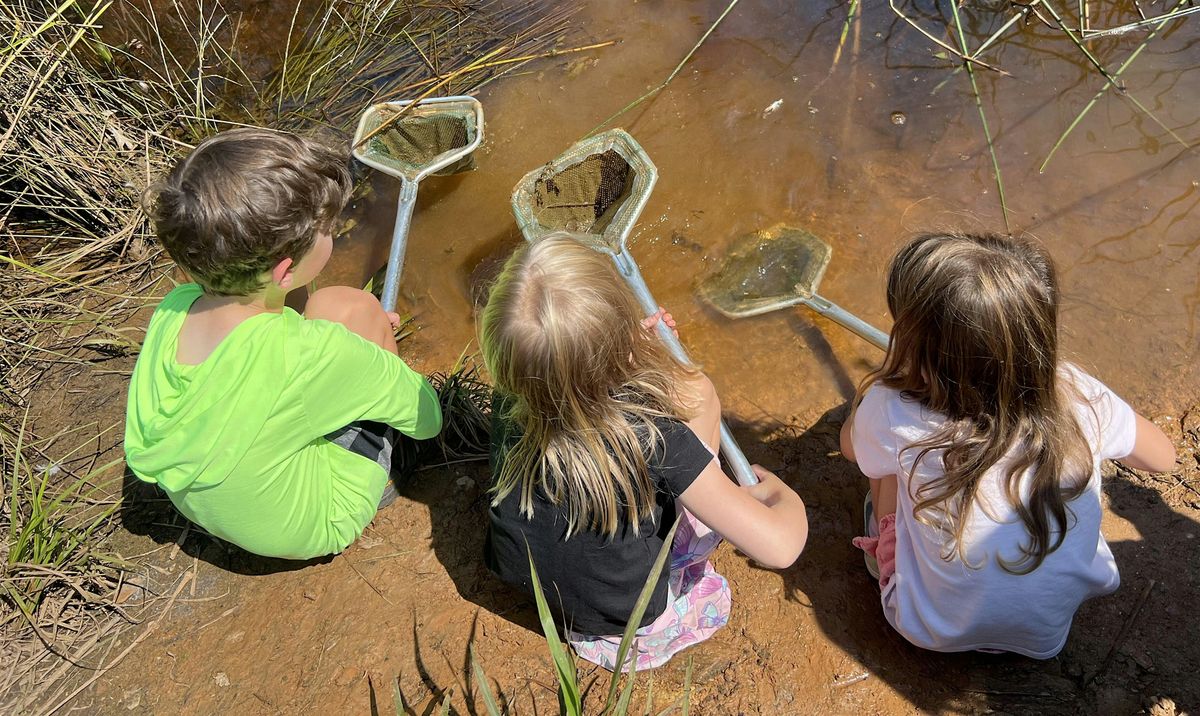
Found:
480,234 -> 808,669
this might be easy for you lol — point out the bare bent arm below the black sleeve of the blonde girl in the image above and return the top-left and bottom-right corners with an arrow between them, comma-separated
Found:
679,459 -> 809,570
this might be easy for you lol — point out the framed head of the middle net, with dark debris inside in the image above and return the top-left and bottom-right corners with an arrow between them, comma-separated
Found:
512,130 -> 658,253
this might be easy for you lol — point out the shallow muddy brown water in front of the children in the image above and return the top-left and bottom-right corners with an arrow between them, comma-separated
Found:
325,0 -> 1200,424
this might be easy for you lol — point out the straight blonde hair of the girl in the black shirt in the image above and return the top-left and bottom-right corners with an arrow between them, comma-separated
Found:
480,233 -> 690,537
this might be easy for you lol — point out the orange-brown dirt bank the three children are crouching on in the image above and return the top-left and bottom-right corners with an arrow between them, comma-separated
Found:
30,343 -> 1200,716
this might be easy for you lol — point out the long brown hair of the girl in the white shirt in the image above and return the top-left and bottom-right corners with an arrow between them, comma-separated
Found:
859,234 -> 1091,574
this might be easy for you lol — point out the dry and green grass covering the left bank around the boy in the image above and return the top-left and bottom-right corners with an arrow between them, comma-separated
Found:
0,0 -> 590,712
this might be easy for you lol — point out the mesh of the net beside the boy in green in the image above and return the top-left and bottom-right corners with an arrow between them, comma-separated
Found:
367,110 -> 474,174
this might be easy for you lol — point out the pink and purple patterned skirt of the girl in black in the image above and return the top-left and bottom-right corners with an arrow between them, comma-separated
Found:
566,505 -> 731,672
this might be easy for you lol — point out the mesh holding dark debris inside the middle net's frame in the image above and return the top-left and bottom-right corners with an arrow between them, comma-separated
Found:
534,149 -> 635,234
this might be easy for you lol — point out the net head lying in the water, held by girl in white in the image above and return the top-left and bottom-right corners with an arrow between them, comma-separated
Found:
700,227 -> 833,317
